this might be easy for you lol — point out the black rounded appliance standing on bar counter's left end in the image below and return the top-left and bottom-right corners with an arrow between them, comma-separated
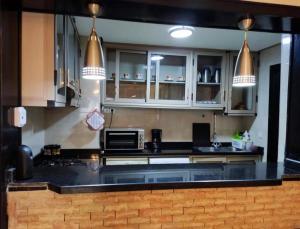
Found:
16,145 -> 33,180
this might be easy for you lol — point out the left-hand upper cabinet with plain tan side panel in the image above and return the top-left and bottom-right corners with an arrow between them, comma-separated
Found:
21,12 -> 80,107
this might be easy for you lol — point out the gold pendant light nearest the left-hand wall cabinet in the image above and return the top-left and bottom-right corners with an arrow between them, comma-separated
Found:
82,3 -> 105,80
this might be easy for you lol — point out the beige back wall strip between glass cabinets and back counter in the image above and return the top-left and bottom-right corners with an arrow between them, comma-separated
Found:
105,108 -> 250,141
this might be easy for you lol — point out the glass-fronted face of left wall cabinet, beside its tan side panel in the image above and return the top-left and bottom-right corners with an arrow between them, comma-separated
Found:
50,15 -> 81,106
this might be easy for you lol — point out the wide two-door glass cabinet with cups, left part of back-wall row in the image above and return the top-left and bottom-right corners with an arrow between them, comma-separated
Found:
104,48 -> 191,106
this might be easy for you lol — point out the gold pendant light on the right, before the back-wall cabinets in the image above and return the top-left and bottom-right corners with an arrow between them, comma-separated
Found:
232,17 -> 256,87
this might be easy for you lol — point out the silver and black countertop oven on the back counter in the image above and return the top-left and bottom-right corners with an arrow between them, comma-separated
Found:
104,128 -> 145,150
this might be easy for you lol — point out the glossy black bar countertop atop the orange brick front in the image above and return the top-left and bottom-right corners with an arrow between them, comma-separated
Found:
8,163 -> 300,194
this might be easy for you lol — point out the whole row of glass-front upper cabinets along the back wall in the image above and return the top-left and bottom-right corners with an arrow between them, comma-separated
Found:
103,44 -> 258,115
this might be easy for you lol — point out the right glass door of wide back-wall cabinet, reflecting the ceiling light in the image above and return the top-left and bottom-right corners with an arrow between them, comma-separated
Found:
148,51 -> 190,105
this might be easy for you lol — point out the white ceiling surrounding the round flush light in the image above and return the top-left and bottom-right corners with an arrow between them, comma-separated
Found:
76,17 -> 281,51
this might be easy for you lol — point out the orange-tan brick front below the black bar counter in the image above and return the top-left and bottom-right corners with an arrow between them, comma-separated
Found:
8,181 -> 300,229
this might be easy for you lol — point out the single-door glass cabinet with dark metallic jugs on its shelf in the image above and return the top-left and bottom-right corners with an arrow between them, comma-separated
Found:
193,52 -> 226,109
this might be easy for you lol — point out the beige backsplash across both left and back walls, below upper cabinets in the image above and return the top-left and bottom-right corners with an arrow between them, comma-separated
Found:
22,106 -> 252,155
